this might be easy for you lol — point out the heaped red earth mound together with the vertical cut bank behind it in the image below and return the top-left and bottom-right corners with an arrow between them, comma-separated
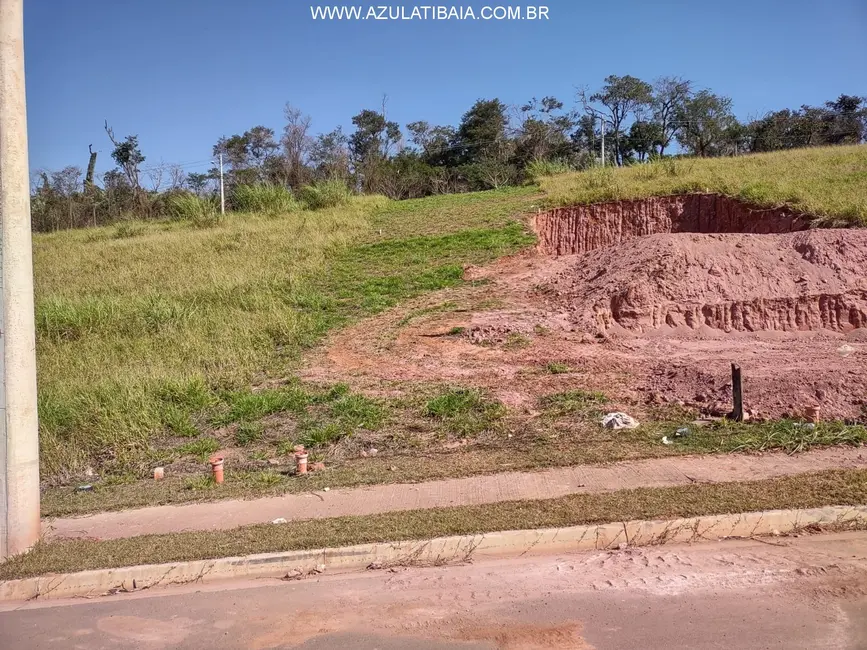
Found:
534,194 -> 867,332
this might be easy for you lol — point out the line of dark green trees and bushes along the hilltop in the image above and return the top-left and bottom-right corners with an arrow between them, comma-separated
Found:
31,75 -> 867,231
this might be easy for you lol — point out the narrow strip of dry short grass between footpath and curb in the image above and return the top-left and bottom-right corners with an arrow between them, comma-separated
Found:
0,470 -> 867,580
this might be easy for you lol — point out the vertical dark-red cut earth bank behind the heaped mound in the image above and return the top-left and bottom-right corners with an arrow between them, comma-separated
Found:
532,194 -> 812,255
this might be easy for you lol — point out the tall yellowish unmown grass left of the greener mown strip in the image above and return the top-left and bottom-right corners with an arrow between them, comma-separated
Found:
34,197 -> 383,478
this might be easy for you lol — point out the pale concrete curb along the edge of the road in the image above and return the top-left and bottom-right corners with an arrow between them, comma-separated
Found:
0,506 -> 867,601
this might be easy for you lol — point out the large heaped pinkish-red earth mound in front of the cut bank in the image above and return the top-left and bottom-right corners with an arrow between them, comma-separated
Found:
538,230 -> 867,333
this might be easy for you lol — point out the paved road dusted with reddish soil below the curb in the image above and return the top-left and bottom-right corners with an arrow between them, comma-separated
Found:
0,532 -> 867,650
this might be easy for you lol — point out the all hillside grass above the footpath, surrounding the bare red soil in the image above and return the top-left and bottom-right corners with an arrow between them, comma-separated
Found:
34,147 -> 867,515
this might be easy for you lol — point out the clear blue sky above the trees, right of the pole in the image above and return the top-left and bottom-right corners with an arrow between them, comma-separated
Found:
25,0 -> 867,177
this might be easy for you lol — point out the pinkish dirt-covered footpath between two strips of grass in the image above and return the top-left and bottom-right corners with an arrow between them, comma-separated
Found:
49,447 -> 867,539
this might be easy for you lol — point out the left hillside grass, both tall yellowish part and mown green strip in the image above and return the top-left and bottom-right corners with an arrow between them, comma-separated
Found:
34,188 -> 537,480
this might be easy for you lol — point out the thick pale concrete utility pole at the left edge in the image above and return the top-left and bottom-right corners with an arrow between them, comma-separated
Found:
0,0 -> 39,560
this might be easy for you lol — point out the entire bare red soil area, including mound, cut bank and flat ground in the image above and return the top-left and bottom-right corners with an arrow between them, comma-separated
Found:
308,195 -> 867,420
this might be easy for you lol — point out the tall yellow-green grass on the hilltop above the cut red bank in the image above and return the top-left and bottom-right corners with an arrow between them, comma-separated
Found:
542,145 -> 867,225
